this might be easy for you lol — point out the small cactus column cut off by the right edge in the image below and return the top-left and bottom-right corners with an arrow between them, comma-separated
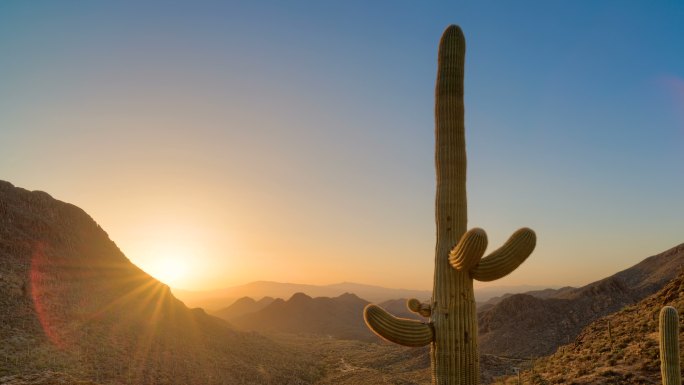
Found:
659,306 -> 682,385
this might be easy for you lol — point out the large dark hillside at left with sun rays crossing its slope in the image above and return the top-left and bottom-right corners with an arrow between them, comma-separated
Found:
0,182 -> 320,384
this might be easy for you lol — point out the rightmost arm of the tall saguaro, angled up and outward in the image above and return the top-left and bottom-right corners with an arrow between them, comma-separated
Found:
470,227 -> 537,282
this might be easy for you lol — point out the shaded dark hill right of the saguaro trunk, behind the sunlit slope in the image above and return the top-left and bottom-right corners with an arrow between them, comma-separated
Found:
478,244 -> 684,357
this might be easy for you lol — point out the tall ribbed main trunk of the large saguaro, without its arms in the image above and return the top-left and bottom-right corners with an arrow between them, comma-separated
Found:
431,26 -> 479,385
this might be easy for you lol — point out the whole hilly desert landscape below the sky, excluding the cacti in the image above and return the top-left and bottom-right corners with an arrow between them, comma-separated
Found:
0,182 -> 684,385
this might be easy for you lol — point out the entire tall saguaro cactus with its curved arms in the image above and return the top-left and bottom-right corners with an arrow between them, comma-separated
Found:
364,25 -> 536,385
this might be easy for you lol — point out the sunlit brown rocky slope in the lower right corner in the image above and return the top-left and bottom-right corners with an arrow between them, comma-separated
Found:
496,274 -> 684,385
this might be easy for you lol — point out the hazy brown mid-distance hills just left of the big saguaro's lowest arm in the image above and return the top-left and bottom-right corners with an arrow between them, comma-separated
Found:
231,293 -> 375,341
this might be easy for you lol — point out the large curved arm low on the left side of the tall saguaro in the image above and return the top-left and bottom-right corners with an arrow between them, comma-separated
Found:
363,305 -> 433,347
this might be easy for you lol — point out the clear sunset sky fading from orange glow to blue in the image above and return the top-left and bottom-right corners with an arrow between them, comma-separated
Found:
0,0 -> 684,290
